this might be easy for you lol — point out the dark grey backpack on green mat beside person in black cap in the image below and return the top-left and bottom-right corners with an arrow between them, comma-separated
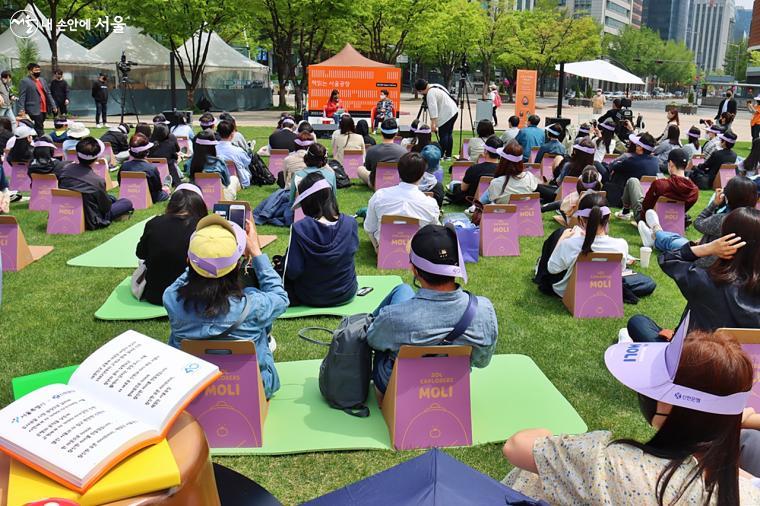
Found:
298,313 -> 372,417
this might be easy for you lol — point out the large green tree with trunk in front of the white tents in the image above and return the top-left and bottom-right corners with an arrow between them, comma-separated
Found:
117,0 -> 247,107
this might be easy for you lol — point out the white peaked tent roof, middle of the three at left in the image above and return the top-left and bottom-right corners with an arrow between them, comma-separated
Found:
90,26 -> 170,66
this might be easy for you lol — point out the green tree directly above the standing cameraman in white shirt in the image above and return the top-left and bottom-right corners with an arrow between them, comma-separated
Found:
407,0 -> 486,87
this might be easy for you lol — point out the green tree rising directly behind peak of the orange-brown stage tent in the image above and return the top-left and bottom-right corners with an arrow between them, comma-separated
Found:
350,0 -> 441,64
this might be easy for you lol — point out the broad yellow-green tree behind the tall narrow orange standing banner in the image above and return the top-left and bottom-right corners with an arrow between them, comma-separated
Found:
498,0 -> 601,96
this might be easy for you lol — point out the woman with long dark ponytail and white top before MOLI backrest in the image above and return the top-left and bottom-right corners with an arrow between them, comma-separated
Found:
534,192 -> 656,301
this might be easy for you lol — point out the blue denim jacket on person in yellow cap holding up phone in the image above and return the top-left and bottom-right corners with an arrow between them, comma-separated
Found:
164,255 -> 289,399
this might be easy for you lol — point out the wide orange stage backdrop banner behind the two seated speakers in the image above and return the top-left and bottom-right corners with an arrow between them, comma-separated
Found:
308,65 -> 401,113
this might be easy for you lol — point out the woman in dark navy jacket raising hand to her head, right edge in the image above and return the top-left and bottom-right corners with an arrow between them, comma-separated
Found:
620,207 -> 760,342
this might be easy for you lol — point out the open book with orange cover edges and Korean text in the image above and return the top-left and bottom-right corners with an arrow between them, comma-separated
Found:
0,330 -> 221,493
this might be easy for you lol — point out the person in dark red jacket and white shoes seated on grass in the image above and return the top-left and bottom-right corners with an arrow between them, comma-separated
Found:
615,148 -> 699,221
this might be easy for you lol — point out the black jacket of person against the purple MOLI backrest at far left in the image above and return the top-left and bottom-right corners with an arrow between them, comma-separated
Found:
58,163 -> 111,230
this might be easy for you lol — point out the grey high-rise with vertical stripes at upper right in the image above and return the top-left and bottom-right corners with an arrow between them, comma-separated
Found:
686,0 -> 735,72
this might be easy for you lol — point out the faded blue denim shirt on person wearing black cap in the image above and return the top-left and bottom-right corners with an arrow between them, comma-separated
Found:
367,288 -> 499,390
